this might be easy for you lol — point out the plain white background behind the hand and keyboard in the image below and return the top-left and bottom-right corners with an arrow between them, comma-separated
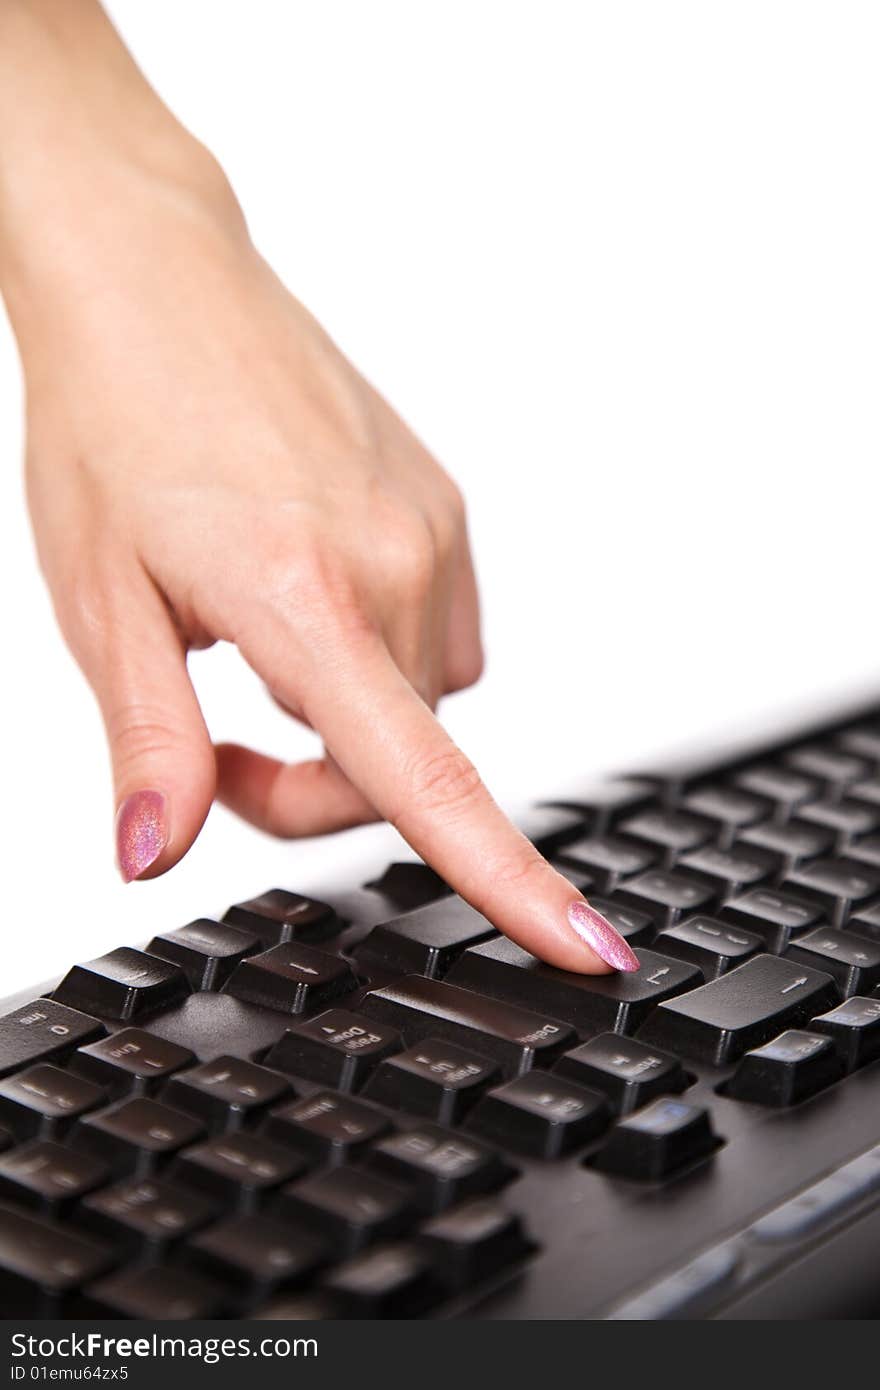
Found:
0,0 -> 880,994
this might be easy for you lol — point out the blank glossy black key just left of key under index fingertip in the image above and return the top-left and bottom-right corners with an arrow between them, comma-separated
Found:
355,898 -> 496,980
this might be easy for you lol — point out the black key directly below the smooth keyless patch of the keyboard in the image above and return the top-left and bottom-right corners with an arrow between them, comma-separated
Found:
163,1056 -> 291,1133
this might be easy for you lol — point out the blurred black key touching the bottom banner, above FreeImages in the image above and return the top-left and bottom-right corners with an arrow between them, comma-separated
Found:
83,1265 -> 229,1322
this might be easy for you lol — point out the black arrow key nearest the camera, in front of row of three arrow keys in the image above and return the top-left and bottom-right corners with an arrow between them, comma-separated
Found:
224,941 -> 357,1013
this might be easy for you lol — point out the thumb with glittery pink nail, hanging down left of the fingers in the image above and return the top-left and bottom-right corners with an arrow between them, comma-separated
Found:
74,571 -> 215,883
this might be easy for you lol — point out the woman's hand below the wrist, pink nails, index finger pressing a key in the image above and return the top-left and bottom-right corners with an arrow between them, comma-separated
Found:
0,2 -> 635,972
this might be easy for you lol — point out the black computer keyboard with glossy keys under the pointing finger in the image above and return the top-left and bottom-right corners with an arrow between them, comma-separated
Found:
0,709 -> 880,1319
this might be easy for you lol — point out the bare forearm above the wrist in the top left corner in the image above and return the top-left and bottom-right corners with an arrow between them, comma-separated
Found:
0,0 -> 236,339
